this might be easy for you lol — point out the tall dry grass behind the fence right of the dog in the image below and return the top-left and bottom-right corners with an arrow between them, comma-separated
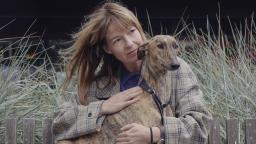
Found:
177,17 -> 256,143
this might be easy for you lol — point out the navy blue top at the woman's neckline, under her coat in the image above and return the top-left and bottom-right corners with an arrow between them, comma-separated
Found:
120,67 -> 140,91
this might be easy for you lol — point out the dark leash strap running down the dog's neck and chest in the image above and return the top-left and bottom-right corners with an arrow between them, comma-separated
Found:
139,80 -> 167,125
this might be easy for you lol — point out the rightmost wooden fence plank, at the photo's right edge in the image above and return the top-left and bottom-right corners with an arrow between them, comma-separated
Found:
245,119 -> 256,144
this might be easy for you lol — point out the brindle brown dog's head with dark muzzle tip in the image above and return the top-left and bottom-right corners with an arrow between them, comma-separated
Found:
137,35 -> 180,72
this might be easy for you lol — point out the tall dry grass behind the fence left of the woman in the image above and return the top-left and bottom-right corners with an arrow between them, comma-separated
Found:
0,32 -> 74,143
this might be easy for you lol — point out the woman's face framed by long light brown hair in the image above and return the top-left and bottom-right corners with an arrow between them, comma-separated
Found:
105,23 -> 144,70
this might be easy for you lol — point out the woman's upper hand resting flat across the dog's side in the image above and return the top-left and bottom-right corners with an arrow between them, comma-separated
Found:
100,86 -> 143,115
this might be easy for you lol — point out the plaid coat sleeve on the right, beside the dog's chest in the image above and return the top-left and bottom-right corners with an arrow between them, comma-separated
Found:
164,58 -> 212,144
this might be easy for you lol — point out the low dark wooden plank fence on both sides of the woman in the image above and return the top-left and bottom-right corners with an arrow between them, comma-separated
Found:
1,119 -> 256,144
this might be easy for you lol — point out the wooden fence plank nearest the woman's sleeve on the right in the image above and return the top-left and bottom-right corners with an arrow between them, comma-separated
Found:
209,119 -> 221,144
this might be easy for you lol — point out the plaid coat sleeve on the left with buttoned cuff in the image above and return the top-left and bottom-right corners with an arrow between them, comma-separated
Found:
52,90 -> 105,141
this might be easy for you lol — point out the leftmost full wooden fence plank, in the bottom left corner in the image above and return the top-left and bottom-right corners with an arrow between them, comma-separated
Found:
6,118 -> 16,144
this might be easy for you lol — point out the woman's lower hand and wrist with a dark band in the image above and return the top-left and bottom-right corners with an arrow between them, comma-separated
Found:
116,123 -> 160,144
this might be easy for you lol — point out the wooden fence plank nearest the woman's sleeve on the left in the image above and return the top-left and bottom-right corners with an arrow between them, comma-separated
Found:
43,118 -> 53,144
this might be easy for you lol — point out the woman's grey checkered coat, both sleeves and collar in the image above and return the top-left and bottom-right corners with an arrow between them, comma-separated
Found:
52,58 -> 212,144
